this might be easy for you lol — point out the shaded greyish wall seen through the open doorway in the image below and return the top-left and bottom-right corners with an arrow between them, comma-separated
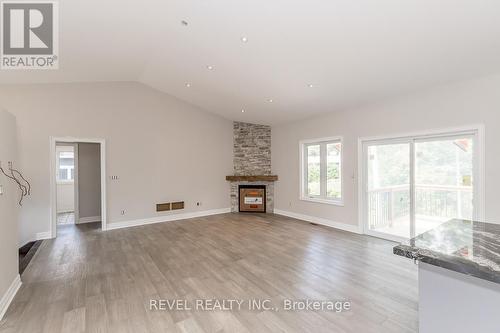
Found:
78,143 -> 101,219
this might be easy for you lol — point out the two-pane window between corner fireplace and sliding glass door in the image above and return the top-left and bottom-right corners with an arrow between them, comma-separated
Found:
301,138 -> 343,205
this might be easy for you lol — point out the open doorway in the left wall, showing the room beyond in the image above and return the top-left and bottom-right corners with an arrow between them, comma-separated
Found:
50,138 -> 106,238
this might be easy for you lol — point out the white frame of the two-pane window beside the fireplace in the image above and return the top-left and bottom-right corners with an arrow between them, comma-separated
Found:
299,136 -> 344,206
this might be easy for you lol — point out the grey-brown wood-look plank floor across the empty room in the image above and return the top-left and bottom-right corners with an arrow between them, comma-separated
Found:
0,214 -> 418,333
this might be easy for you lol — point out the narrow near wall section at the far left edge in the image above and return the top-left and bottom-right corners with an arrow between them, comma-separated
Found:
0,110 -> 19,319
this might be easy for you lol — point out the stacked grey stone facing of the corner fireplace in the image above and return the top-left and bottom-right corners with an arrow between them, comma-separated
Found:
231,121 -> 274,213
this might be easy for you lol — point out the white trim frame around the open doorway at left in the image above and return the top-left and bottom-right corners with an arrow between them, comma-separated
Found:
49,136 -> 107,238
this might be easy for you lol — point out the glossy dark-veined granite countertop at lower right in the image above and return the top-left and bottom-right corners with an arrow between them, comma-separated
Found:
393,220 -> 500,283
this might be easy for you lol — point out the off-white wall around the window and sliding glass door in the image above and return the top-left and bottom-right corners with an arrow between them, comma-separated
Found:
272,76 -> 500,225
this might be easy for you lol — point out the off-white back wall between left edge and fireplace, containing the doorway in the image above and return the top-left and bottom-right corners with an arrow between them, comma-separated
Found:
0,83 -> 233,243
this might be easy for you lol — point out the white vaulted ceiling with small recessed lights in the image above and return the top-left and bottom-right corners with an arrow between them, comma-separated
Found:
0,0 -> 500,124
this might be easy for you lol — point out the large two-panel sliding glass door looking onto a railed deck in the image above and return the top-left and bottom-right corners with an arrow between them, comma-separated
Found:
363,129 -> 477,240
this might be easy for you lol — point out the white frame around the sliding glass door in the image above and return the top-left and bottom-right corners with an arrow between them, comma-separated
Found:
358,124 -> 486,242
